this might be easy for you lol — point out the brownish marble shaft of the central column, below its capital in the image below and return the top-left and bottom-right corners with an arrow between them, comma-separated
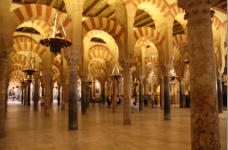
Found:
123,67 -> 131,125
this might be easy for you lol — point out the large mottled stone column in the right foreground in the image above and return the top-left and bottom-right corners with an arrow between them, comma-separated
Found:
178,0 -> 221,150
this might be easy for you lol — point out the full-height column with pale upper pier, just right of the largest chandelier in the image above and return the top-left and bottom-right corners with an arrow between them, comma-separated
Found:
68,0 -> 84,130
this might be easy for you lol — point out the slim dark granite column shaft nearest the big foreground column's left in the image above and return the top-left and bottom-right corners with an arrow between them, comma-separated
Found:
164,75 -> 171,120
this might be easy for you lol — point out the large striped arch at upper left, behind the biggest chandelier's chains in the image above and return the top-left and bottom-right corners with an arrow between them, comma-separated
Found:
13,4 -> 70,28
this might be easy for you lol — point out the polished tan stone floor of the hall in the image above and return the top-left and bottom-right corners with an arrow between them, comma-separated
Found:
0,104 -> 227,150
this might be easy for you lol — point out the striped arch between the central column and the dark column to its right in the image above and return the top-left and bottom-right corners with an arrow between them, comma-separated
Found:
134,27 -> 164,46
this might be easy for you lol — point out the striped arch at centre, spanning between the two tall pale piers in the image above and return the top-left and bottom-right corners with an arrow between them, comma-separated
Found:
82,17 -> 124,43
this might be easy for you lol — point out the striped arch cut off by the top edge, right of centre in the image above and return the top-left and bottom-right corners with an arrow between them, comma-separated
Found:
123,0 -> 173,17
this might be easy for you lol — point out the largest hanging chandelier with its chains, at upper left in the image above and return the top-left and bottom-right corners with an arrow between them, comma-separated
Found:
40,0 -> 72,54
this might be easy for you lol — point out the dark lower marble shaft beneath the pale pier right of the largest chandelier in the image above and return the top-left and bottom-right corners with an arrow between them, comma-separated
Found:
68,64 -> 78,130
